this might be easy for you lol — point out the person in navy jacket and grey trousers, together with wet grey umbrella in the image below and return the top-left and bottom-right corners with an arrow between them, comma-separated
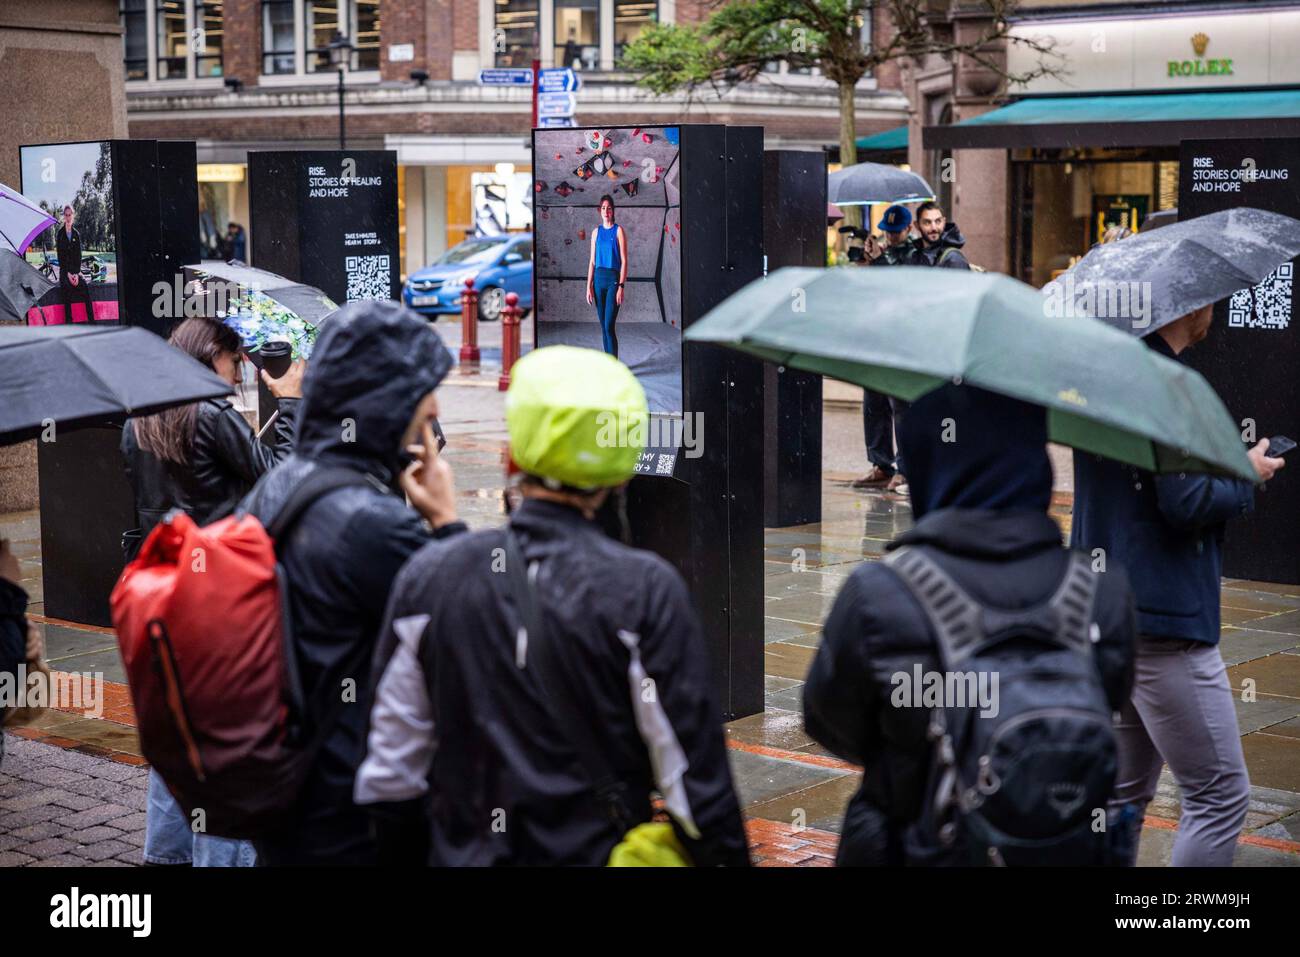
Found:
1043,207 -> 1300,867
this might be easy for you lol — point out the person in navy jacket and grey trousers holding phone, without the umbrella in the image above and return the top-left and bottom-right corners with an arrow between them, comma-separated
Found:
1071,303 -> 1286,867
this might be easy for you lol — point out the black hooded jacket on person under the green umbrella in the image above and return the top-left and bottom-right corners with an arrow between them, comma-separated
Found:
803,385 -> 1134,866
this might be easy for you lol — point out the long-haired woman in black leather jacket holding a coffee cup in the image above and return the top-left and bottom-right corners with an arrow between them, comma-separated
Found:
122,317 -> 304,867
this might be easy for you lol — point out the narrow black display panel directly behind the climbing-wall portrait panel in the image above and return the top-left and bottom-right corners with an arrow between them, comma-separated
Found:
763,150 -> 826,528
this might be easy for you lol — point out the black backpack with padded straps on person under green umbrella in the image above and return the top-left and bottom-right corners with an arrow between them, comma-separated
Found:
884,547 -> 1117,866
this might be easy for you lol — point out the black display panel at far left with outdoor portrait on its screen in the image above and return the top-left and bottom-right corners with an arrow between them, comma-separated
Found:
20,139 -> 199,625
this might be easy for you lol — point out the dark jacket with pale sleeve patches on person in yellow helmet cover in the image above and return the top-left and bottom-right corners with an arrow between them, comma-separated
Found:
356,499 -> 749,866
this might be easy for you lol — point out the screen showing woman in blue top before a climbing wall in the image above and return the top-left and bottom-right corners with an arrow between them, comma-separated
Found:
533,126 -> 683,415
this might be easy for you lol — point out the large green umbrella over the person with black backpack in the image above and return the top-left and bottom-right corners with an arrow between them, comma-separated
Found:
685,267 -> 1256,481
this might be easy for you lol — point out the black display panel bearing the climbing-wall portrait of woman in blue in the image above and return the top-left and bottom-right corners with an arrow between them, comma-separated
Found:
533,125 -> 763,718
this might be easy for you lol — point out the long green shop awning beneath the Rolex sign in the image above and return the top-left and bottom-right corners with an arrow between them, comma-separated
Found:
922,90 -> 1300,150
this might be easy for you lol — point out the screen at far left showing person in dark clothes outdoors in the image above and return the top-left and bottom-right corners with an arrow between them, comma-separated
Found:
20,142 -> 120,325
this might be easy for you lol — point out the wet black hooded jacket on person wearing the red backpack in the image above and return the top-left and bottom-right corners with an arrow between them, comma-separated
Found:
242,302 -> 464,865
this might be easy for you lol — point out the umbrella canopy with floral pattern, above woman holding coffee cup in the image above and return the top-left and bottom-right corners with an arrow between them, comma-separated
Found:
185,261 -> 338,359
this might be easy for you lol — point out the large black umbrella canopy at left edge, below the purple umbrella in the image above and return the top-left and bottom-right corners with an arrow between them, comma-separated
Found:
0,326 -> 233,445
